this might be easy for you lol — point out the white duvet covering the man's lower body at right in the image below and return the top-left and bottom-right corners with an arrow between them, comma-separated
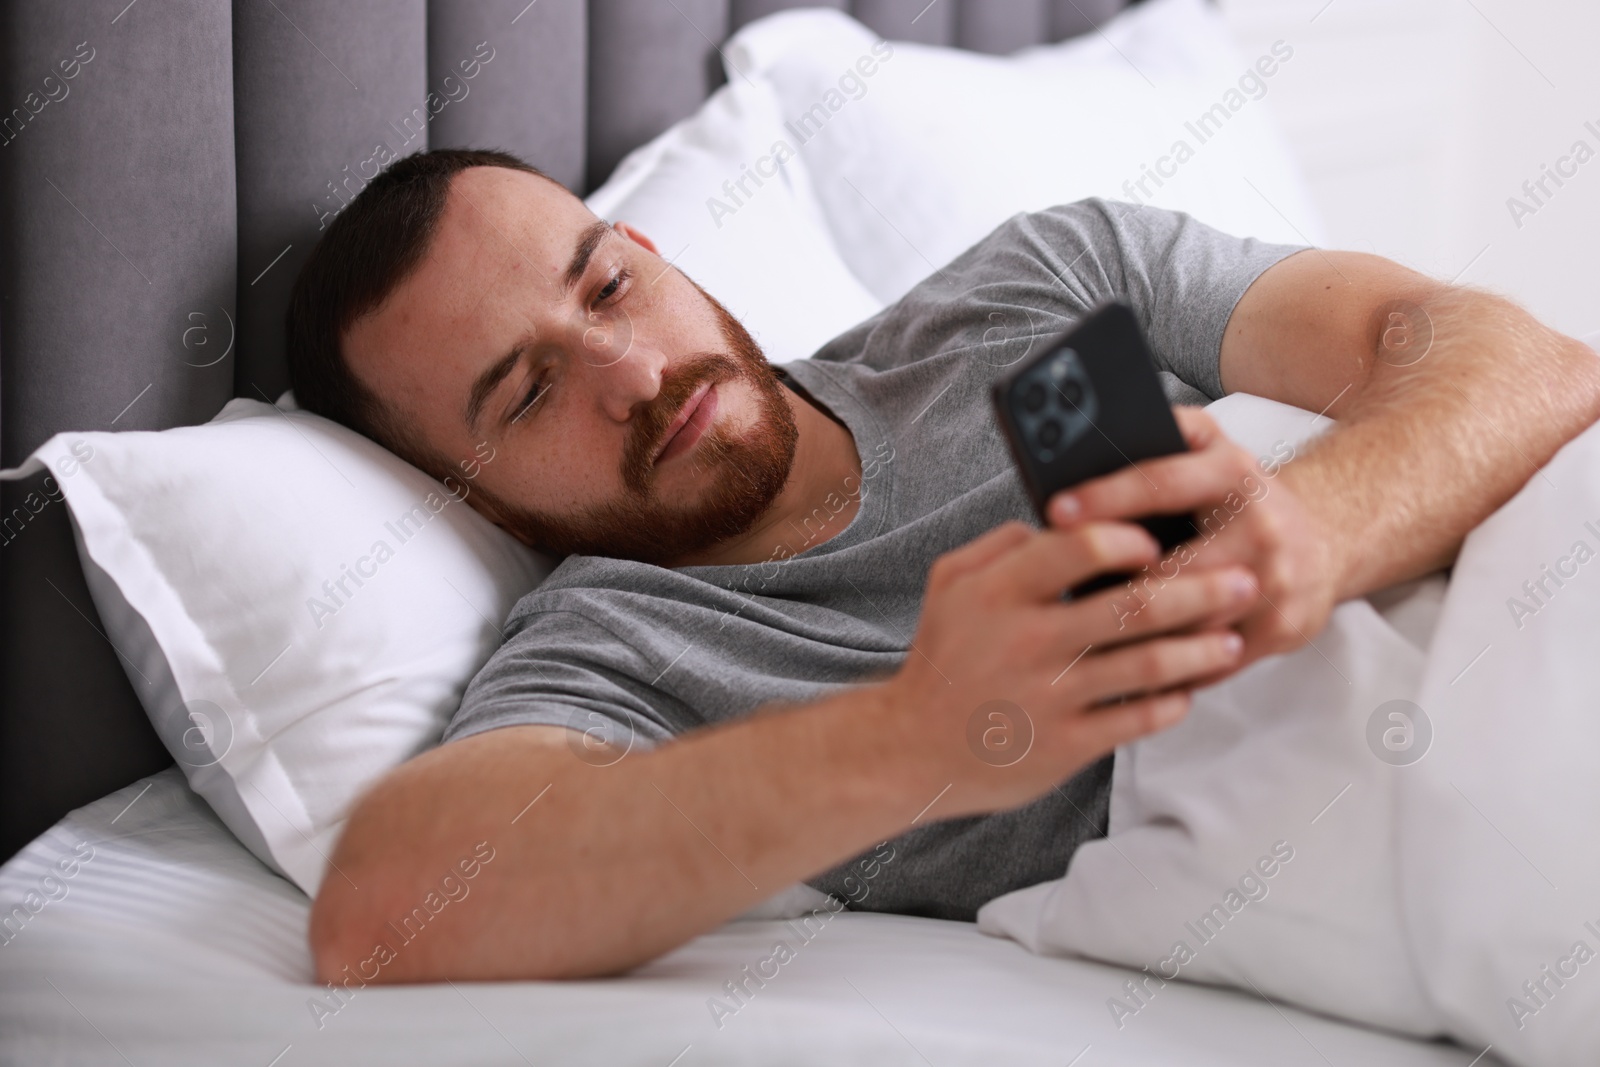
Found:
979,397 -> 1600,1067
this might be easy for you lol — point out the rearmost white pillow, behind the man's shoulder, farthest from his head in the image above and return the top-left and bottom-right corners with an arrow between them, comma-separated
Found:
725,0 -> 1322,302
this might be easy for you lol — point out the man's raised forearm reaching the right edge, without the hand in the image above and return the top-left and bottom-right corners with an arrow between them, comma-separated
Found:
1280,286 -> 1600,600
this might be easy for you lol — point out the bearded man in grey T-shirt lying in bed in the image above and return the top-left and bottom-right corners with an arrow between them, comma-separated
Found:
288,152 -> 1600,981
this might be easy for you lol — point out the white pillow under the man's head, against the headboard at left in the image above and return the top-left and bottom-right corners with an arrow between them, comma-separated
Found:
6,400 -> 549,896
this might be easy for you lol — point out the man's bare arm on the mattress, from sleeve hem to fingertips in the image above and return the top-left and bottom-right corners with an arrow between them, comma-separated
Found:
310,523 -> 1254,982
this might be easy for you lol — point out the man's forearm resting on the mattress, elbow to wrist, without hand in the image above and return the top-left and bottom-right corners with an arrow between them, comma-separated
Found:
312,688 -> 938,982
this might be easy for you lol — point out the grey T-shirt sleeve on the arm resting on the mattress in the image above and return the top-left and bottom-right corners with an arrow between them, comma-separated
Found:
443,611 -> 693,750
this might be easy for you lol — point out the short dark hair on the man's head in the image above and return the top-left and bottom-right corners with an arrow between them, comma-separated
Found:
283,149 -> 560,478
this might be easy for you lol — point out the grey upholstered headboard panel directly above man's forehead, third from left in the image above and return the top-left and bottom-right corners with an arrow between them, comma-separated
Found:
427,0 -> 589,194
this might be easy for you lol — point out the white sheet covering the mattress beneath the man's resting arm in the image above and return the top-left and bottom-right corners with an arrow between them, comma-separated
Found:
0,768 -> 1493,1067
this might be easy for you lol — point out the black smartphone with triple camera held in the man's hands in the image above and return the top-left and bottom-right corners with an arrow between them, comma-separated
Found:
994,302 -> 1198,597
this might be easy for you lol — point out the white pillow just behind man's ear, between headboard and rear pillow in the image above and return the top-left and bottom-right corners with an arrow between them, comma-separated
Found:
587,77 -> 882,363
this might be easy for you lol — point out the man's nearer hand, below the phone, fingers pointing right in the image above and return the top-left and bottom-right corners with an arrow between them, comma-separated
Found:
877,523 -> 1256,817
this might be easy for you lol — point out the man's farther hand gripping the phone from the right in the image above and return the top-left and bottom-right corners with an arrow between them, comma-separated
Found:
1050,406 -> 1342,671
